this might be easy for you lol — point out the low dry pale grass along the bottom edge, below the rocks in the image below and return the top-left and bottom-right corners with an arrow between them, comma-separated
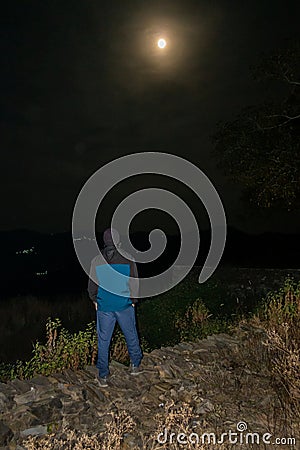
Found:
22,402 -> 296,450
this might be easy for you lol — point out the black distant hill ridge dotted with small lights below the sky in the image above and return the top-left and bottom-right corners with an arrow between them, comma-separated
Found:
0,227 -> 300,295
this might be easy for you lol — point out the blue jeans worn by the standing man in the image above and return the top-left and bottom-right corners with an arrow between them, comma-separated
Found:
96,306 -> 142,378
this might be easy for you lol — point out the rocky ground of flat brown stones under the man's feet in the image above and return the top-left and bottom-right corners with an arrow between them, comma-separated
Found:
0,326 -> 300,449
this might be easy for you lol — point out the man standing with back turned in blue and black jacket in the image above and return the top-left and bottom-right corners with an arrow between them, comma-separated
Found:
88,229 -> 142,387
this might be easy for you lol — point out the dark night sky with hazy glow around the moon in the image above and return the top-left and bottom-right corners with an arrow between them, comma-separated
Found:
0,0 -> 300,233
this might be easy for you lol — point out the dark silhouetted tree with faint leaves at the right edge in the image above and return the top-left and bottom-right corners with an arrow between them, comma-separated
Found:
212,43 -> 300,209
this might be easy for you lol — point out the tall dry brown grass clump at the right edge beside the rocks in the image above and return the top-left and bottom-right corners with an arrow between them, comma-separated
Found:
236,278 -> 300,435
